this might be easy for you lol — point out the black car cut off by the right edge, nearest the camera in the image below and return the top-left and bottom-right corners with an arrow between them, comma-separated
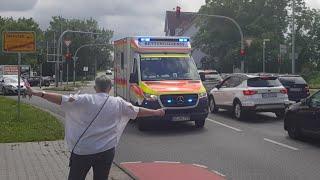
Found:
284,91 -> 320,139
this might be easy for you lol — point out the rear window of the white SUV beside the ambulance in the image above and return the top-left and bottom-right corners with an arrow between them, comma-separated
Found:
247,77 -> 281,87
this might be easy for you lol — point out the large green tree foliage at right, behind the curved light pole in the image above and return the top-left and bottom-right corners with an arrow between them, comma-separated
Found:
193,0 -> 320,72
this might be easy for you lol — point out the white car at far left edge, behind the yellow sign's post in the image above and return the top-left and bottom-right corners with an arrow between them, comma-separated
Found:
0,75 -> 26,95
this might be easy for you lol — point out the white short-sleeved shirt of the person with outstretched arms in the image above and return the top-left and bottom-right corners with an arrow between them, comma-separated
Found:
61,93 -> 139,155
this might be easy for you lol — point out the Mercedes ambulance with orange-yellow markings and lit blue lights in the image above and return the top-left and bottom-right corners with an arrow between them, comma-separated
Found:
114,36 -> 208,130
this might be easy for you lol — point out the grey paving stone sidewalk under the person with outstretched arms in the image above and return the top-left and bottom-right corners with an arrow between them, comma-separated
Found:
0,141 -> 131,180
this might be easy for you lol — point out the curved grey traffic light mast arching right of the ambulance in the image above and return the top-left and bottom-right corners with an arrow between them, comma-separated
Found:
185,12 -> 244,73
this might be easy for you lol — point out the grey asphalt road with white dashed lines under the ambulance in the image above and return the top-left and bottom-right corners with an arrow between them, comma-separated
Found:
6,78 -> 320,180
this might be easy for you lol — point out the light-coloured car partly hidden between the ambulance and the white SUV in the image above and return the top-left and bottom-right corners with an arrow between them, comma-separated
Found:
199,70 -> 222,93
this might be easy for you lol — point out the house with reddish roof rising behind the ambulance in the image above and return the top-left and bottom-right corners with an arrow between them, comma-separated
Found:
164,11 -> 207,68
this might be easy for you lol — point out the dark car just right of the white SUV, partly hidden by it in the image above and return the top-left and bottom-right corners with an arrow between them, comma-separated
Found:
278,75 -> 310,102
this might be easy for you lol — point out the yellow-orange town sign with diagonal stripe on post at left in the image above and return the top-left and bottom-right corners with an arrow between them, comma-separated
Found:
2,31 -> 36,53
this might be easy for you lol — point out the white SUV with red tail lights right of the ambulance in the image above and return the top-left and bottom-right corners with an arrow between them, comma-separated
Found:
209,74 -> 289,120
